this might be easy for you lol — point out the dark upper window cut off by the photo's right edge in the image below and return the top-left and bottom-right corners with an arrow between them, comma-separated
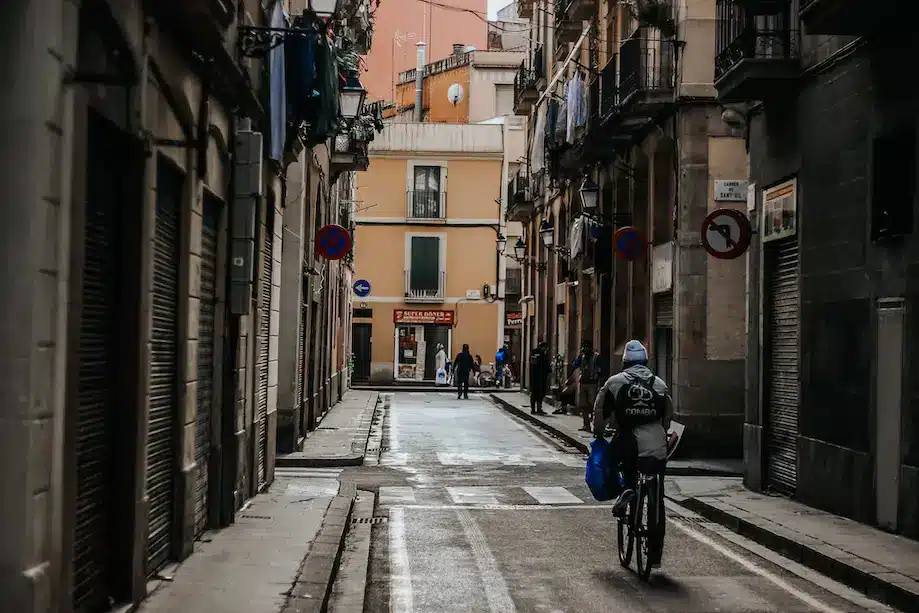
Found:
871,125 -> 916,240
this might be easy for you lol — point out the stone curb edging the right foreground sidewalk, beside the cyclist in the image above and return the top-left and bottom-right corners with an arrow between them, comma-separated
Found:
671,498 -> 919,613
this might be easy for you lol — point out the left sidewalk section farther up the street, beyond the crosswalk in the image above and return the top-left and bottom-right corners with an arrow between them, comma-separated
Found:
276,389 -> 379,468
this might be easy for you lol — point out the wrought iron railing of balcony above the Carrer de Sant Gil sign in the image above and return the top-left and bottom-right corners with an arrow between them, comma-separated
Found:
715,0 -> 800,81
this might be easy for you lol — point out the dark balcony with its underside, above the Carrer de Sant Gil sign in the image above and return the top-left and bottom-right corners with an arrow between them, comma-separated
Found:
715,0 -> 801,102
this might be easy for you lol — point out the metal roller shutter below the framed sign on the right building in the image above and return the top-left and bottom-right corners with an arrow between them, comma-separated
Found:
766,238 -> 799,494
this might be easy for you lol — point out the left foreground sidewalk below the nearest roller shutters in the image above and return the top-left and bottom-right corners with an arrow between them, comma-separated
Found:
137,475 -> 357,613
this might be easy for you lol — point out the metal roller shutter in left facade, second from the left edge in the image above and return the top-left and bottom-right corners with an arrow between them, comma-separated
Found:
147,160 -> 183,575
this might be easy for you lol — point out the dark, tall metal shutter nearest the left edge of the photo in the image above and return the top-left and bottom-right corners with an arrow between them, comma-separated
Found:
73,126 -> 118,611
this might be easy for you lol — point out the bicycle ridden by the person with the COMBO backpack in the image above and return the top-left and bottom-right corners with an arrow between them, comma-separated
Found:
617,458 -> 666,581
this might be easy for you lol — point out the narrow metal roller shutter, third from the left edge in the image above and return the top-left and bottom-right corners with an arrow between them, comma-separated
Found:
195,198 -> 220,536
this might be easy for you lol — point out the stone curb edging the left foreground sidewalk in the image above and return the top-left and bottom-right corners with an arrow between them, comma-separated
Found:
281,483 -> 357,613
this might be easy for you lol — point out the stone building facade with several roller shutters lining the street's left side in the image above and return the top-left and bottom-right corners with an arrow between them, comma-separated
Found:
0,0 -> 376,612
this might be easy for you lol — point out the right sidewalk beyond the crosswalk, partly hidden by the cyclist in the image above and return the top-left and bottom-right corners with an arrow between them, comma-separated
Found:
491,393 -> 743,477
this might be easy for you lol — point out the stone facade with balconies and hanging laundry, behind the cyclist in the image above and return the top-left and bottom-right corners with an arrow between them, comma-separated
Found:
511,0 -> 746,457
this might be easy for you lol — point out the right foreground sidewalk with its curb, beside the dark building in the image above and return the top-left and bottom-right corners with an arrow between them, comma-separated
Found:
667,477 -> 919,613
